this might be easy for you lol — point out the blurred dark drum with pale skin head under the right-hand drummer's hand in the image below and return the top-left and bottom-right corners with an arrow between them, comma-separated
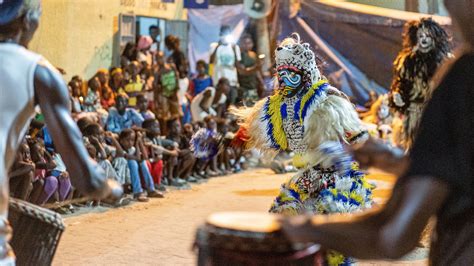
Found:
195,212 -> 322,266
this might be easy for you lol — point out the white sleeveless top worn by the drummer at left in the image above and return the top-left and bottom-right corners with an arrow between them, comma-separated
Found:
0,43 -> 42,208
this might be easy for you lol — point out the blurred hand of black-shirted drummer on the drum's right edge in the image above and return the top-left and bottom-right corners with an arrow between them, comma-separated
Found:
280,215 -> 315,243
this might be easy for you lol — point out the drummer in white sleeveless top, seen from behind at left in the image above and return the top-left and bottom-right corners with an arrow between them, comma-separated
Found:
0,0 -> 122,265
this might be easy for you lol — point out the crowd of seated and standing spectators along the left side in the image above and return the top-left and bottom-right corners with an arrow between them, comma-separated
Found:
9,23 -> 264,213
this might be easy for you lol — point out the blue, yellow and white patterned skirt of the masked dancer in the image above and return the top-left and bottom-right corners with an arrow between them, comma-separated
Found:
270,163 -> 373,265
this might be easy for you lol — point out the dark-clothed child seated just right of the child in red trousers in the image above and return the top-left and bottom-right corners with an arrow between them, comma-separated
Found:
168,119 -> 201,182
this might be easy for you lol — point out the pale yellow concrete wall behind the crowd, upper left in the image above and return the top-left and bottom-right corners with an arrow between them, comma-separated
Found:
30,0 -> 186,79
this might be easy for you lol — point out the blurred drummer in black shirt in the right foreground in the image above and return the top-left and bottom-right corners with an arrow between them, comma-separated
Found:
283,0 -> 474,265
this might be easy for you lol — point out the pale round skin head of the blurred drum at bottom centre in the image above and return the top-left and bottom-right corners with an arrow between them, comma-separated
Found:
207,212 -> 280,233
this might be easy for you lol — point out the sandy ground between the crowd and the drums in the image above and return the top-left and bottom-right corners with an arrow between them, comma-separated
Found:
54,169 -> 426,265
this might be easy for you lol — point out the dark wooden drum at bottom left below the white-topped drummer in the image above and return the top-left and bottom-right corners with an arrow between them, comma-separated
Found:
8,199 -> 64,265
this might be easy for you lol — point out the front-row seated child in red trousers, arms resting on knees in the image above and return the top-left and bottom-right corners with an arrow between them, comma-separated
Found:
143,119 -> 186,187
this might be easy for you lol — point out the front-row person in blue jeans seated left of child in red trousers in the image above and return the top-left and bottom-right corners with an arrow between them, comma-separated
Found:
119,129 -> 163,202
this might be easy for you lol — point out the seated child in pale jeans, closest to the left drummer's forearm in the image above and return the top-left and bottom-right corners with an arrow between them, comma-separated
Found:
84,123 -> 131,186
